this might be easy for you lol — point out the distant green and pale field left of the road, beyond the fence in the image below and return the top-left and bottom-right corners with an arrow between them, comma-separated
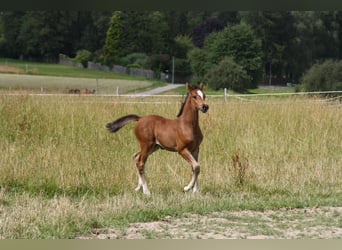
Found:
0,58 -> 163,94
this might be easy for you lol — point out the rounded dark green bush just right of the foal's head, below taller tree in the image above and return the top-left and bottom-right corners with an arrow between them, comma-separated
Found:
205,57 -> 251,91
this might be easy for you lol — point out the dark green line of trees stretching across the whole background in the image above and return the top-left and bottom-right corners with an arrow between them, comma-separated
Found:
0,11 -> 342,89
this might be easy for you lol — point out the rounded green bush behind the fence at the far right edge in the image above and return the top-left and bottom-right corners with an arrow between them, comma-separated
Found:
301,60 -> 342,91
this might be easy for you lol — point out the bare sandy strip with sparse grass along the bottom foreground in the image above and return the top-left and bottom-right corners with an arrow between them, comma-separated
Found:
77,207 -> 342,239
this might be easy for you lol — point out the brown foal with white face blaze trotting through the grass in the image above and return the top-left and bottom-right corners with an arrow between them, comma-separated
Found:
106,84 -> 209,195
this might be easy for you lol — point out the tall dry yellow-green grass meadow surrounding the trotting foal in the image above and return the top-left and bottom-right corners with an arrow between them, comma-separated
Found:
0,92 -> 342,239
